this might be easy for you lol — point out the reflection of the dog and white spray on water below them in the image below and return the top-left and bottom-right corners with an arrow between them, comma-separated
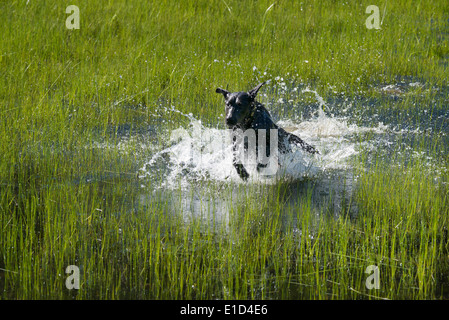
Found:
140,170 -> 357,235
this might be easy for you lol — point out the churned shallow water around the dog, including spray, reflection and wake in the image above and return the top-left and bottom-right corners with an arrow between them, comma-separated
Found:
128,87 -> 448,227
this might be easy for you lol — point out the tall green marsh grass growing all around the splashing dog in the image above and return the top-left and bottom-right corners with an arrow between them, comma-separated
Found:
0,0 -> 449,299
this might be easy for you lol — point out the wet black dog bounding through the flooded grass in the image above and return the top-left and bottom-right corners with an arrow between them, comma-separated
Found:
215,82 -> 318,180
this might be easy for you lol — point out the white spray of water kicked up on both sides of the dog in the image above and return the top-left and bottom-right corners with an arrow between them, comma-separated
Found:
141,88 -> 384,189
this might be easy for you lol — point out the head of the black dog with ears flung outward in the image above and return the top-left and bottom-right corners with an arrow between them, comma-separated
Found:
215,82 -> 265,127
